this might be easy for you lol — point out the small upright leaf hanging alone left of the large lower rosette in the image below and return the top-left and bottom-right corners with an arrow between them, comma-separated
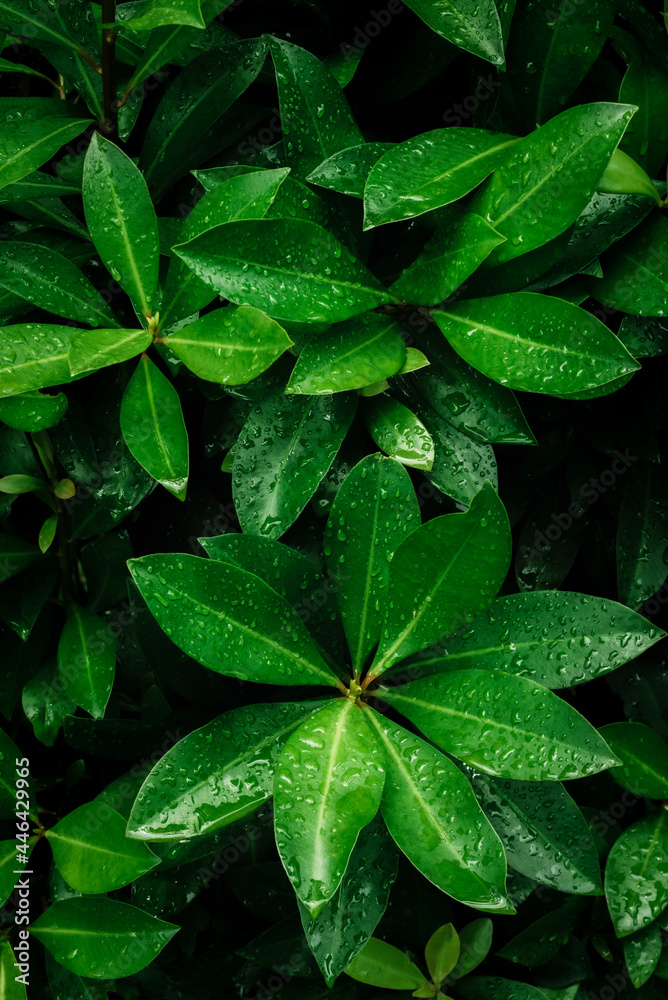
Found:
58,604 -> 116,719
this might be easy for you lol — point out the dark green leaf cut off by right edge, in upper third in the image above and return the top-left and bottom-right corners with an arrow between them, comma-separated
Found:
591,214 -> 668,316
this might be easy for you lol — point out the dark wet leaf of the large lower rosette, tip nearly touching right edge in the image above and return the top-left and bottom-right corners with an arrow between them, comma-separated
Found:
421,590 -> 663,688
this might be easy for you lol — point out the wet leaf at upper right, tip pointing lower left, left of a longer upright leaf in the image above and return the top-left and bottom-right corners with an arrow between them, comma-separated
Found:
364,126 -> 518,229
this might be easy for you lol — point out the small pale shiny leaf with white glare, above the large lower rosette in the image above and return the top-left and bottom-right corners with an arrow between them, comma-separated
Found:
364,396 -> 434,470
